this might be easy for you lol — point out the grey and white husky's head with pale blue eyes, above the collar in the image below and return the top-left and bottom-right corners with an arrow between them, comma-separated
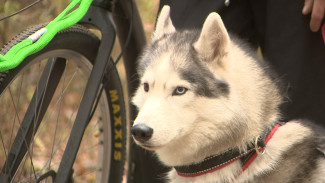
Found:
131,6 -> 280,166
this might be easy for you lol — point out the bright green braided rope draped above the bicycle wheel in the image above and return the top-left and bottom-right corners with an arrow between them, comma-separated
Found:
0,0 -> 92,72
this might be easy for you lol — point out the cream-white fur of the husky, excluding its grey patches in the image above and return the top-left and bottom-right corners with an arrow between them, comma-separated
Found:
133,6 -> 325,183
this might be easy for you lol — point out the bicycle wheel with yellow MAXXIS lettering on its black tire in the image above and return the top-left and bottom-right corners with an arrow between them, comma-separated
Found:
0,25 -> 127,183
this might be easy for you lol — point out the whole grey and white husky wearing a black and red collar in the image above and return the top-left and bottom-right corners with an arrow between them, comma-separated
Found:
131,6 -> 325,183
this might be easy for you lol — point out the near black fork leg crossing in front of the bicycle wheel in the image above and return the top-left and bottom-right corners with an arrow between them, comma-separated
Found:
55,2 -> 116,183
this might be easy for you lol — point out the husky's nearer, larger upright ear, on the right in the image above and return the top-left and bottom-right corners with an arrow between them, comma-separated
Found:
193,13 -> 230,61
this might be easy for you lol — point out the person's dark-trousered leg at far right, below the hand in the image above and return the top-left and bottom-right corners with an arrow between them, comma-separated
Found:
260,0 -> 325,126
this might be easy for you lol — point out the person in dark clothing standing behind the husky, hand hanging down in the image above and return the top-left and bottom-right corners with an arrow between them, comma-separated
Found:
159,0 -> 325,127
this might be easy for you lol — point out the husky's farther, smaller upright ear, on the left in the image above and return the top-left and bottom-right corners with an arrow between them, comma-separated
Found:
152,5 -> 176,41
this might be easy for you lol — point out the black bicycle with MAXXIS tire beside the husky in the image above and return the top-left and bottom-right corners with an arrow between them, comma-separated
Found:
0,0 -> 164,183
